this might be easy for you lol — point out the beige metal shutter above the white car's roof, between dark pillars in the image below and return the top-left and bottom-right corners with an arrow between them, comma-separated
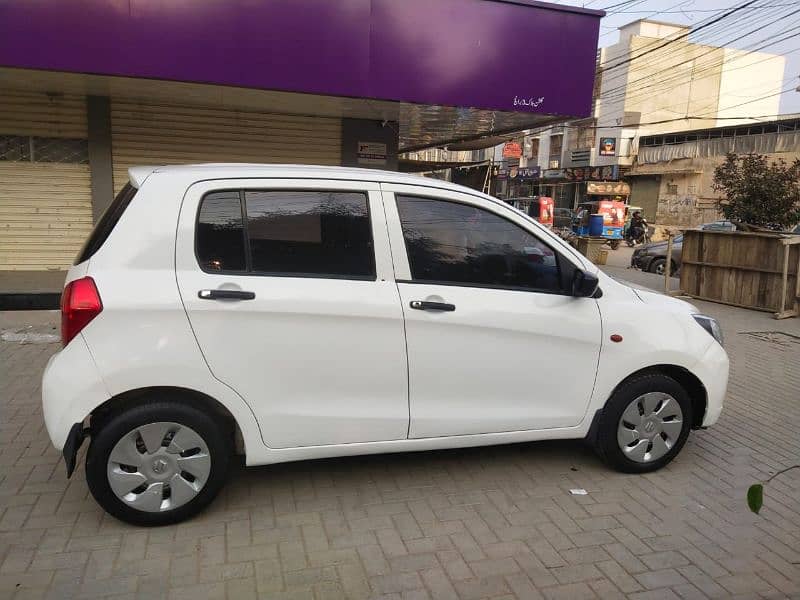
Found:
111,100 -> 341,191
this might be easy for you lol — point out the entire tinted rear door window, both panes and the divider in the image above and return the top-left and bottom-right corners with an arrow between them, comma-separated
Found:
195,190 -> 375,279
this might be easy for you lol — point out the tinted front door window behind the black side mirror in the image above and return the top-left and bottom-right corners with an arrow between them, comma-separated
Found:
396,195 -> 565,293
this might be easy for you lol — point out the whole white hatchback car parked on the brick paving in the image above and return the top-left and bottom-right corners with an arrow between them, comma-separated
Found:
42,165 -> 728,525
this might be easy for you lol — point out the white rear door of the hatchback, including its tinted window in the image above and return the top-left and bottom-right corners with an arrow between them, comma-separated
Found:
175,179 -> 408,448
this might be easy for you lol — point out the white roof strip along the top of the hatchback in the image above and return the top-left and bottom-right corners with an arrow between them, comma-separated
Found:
128,163 -> 484,200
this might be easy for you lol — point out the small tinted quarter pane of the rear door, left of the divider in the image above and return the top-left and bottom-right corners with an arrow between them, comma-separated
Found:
196,191 -> 246,271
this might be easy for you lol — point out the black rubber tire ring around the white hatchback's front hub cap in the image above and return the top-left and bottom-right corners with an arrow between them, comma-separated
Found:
595,372 -> 692,473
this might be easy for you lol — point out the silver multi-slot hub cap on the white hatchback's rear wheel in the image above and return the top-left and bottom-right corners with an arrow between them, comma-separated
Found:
107,422 -> 211,512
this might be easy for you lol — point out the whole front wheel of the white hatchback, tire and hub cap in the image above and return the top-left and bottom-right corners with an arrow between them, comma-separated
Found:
595,373 -> 692,473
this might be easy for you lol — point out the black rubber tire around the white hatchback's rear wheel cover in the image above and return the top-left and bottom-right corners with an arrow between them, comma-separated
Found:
86,401 -> 233,526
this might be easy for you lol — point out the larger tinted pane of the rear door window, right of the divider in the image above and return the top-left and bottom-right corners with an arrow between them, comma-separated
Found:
245,191 -> 375,279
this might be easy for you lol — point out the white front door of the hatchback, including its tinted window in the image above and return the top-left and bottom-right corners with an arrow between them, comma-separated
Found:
382,184 -> 601,438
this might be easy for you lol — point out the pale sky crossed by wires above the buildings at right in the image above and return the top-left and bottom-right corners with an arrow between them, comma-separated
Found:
550,0 -> 800,114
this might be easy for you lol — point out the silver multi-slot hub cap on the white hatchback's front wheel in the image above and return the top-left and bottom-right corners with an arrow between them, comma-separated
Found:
617,392 -> 683,463
